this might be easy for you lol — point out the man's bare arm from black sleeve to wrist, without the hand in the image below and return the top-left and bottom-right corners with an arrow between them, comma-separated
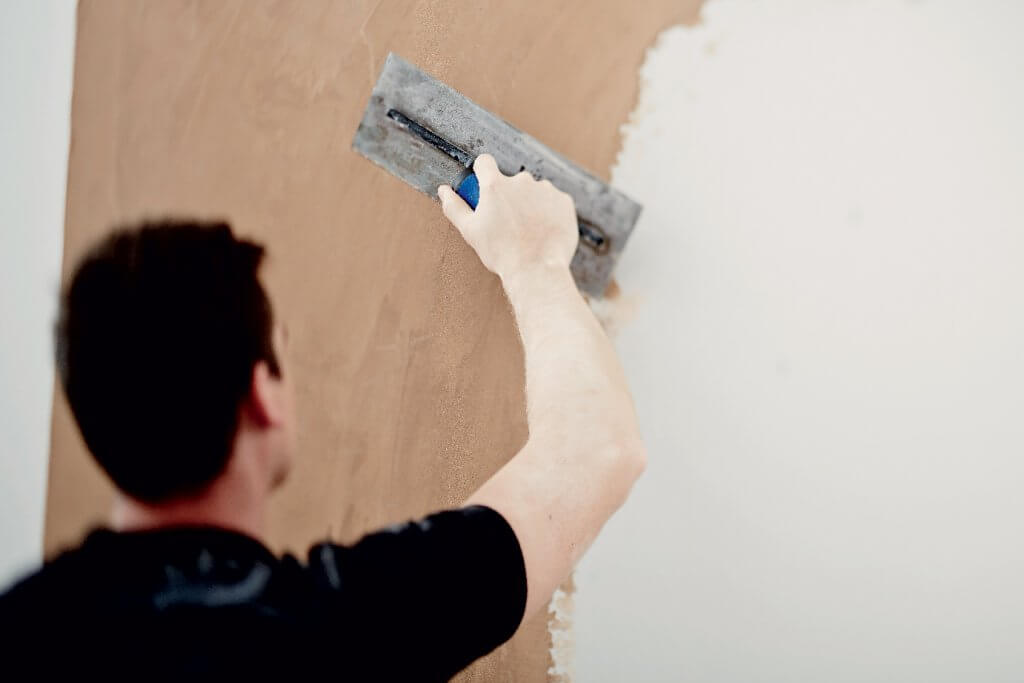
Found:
470,267 -> 645,612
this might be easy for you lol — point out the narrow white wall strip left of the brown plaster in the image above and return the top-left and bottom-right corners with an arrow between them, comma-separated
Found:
0,0 -> 75,587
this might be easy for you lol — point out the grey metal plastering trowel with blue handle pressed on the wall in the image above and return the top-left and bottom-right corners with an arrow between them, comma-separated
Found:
352,53 -> 640,296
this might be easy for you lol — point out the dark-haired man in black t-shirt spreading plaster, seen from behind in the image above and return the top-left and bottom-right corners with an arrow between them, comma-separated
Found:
0,155 -> 645,680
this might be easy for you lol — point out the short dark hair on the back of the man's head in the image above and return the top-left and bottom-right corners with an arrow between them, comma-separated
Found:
56,220 -> 280,503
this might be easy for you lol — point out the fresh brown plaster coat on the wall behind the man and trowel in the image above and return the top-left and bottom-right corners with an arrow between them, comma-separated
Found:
45,0 -> 698,681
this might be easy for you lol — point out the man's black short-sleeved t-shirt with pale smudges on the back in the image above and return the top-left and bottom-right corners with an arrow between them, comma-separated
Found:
0,507 -> 526,681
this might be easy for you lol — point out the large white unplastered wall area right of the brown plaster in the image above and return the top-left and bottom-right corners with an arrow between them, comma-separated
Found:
574,0 -> 1024,683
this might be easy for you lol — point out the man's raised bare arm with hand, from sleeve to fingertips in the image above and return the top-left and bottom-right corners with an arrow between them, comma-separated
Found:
438,155 -> 646,616
